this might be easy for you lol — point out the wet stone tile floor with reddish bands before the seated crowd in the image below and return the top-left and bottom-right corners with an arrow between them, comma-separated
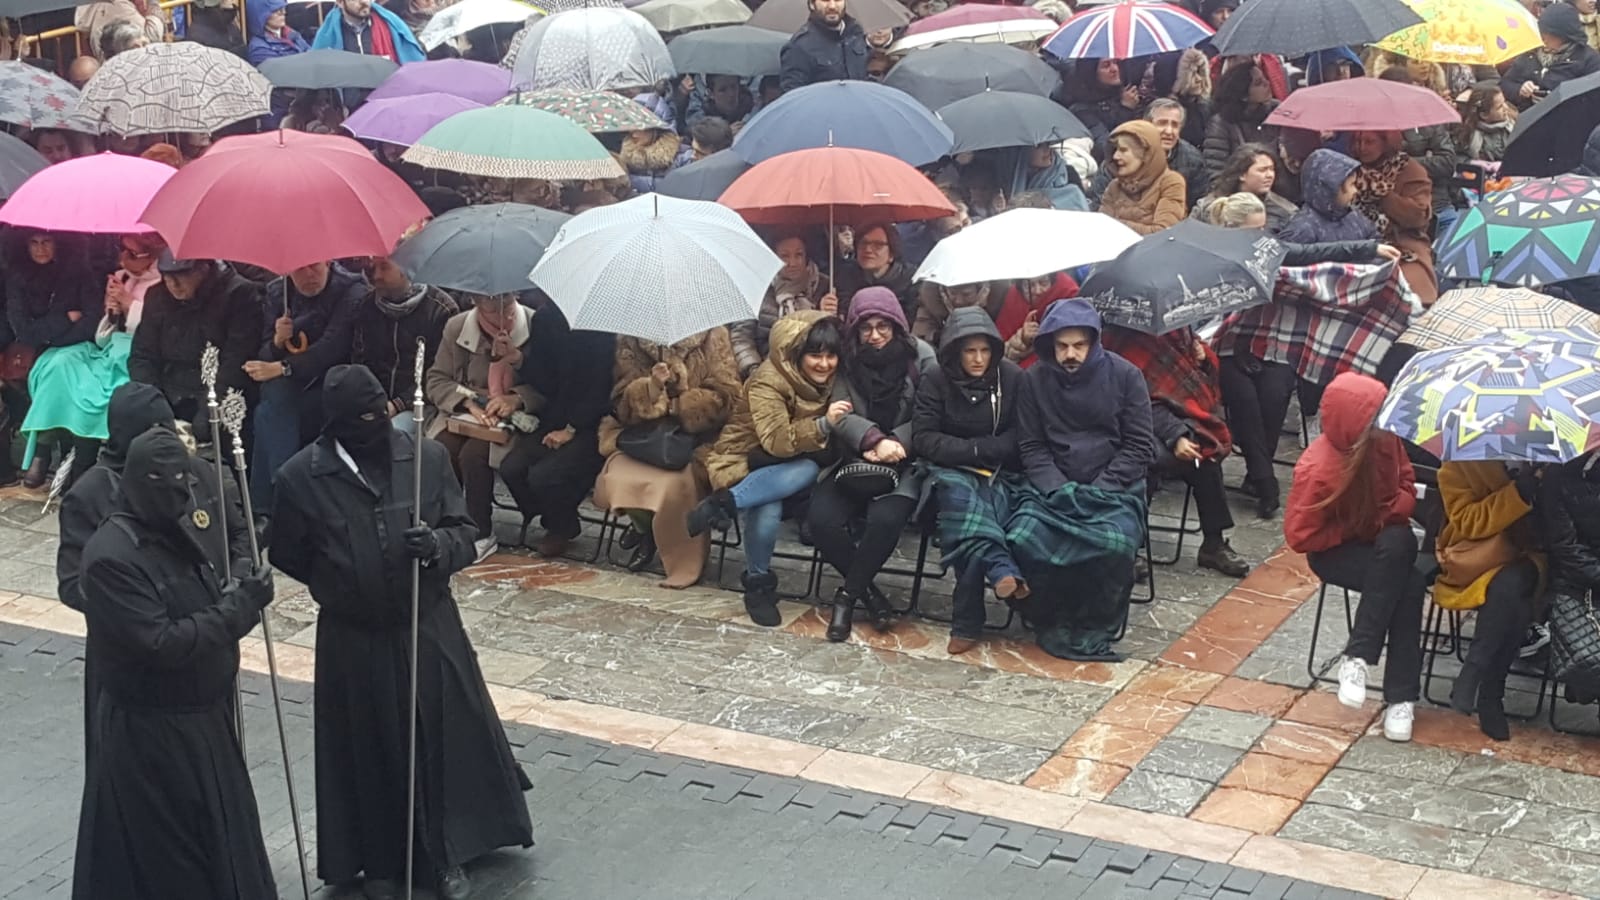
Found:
0,435 -> 1600,895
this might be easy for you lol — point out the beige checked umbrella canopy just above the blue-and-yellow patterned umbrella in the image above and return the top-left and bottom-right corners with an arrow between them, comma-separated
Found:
1395,285 -> 1600,351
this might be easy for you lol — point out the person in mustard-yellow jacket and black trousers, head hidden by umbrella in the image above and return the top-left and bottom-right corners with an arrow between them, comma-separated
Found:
1434,461 -> 1542,740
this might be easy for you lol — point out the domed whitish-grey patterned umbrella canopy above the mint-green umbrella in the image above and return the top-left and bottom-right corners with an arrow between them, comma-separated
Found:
510,8 -> 674,91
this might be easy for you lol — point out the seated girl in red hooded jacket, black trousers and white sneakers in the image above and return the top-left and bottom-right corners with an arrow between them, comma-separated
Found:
1283,372 -> 1427,741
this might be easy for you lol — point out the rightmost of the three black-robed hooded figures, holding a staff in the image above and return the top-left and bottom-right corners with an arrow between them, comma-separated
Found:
272,365 -> 533,900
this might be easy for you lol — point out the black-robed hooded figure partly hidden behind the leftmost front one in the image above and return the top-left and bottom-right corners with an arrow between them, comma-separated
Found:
56,381 -> 250,762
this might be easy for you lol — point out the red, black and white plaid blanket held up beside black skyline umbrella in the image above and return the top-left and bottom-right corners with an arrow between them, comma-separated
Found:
1213,263 -> 1416,384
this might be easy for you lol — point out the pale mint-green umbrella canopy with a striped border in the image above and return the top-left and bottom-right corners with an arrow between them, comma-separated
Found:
402,106 -> 622,181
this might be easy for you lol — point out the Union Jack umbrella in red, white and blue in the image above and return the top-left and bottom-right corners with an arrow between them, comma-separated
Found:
1042,0 -> 1213,59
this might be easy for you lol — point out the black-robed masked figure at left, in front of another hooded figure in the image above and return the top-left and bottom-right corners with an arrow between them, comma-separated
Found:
72,428 -> 278,900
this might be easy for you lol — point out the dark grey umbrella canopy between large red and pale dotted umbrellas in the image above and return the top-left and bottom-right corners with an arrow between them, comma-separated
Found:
392,203 -> 573,295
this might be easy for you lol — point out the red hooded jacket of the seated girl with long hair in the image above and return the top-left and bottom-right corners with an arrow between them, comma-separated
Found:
1283,372 -> 1416,552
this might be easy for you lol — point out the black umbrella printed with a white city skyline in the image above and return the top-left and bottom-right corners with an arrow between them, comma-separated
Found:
1082,219 -> 1283,335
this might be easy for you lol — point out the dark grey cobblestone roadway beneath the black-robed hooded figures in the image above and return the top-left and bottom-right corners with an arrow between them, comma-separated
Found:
0,625 -> 1370,900
